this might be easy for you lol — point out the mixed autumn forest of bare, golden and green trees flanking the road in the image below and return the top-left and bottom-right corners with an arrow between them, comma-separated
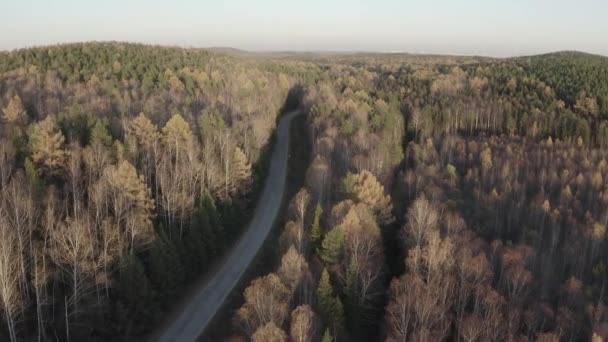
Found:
0,42 -> 608,342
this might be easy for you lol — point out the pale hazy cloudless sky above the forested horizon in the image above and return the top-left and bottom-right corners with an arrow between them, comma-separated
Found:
0,0 -> 608,56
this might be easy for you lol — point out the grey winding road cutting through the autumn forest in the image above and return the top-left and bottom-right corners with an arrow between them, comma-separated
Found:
158,111 -> 302,342
